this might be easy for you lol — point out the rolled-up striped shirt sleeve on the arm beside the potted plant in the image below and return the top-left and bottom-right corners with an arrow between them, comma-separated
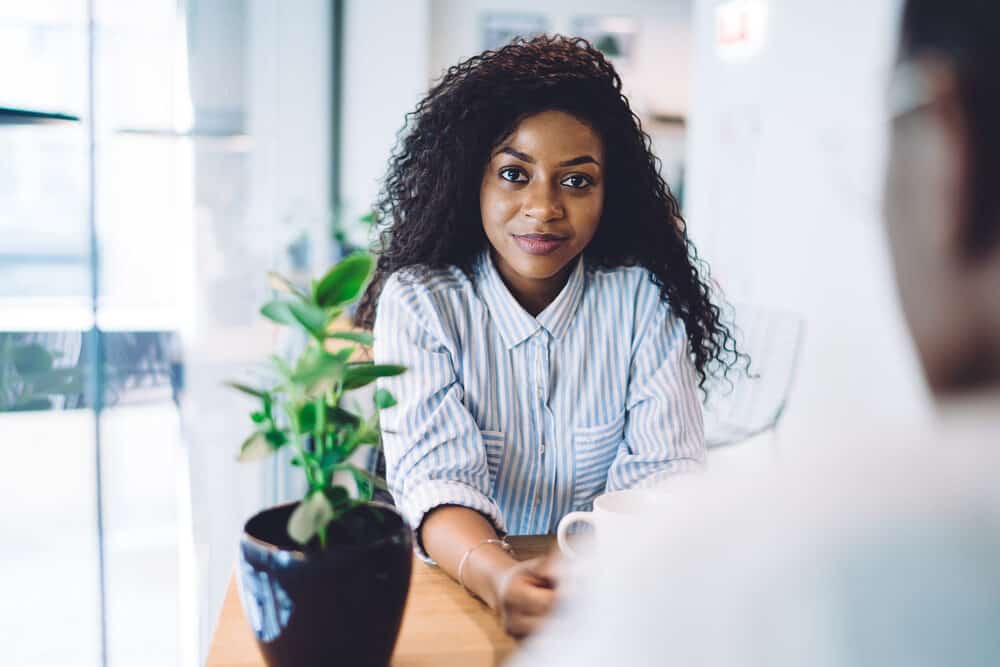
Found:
374,276 -> 505,558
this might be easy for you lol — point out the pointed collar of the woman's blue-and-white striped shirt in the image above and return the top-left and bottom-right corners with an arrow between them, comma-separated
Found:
476,249 -> 585,349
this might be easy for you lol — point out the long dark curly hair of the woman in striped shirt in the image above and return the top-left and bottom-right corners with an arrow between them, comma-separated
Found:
355,36 -> 743,390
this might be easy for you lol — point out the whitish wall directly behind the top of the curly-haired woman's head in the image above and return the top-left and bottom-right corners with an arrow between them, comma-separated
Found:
340,0 -> 691,227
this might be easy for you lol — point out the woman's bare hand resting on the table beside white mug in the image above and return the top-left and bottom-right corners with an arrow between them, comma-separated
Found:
495,557 -> 557,637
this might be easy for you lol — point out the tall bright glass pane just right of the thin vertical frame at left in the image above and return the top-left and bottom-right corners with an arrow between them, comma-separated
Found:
94,0 -> 197,667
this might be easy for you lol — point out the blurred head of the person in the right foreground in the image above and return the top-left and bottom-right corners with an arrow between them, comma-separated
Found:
886,0 -> 1000,393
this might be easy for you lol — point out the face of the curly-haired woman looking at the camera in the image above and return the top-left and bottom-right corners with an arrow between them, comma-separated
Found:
479,111 -> 604,292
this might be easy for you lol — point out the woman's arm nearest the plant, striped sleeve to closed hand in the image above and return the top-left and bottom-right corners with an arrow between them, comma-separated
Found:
375,279 -> 554,635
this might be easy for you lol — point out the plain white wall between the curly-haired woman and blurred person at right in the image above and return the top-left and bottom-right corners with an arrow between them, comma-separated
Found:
687,0 -> 928,446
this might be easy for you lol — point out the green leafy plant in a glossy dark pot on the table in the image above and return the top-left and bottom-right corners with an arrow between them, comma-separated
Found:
231,254 -> 412,667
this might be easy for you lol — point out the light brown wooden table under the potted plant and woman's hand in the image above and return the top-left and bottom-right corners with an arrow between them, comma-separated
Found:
205,535 -> 555,667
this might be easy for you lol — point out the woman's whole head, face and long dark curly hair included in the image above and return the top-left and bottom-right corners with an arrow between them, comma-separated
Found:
356,36 -> 735,388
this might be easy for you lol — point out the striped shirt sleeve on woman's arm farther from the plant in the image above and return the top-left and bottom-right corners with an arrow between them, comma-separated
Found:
607,290 -> 705,491
